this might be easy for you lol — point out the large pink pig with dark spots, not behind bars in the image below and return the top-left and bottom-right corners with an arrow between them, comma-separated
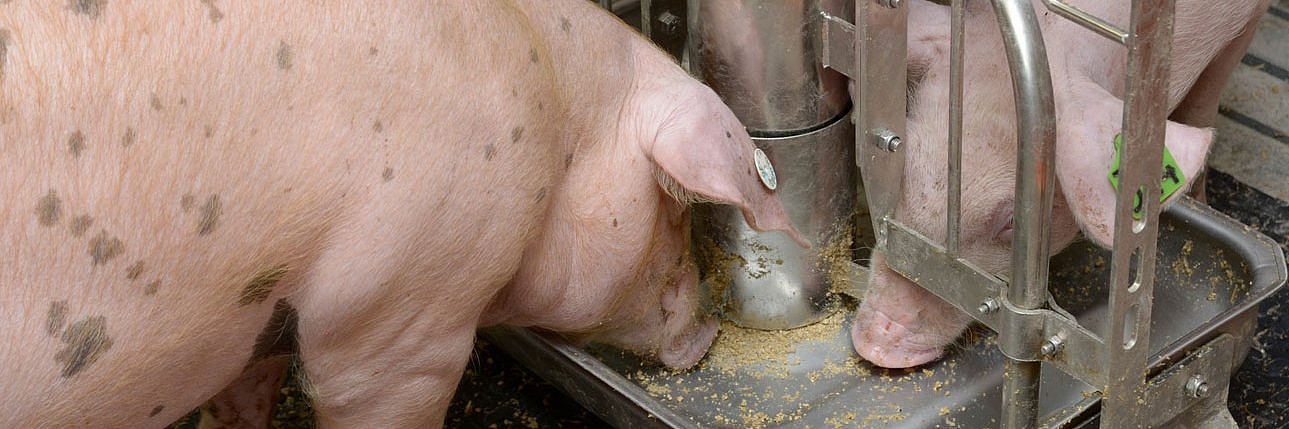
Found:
0,0 -> 799,428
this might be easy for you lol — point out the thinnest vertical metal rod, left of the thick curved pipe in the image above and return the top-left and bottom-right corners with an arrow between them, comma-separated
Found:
945,0 -> 967,253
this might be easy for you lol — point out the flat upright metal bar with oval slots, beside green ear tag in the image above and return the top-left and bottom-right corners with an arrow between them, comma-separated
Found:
1101,0 -> 1174,428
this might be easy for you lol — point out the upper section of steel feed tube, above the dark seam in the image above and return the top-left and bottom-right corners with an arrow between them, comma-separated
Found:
690,0 -> 851,137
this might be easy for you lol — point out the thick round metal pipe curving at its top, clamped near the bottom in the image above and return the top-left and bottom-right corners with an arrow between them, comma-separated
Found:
993,0 -> 1056,428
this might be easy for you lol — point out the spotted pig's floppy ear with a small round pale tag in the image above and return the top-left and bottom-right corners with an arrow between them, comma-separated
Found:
643,84 -> 809,247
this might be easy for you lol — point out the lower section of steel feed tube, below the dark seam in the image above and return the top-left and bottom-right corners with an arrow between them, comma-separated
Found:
693,113 -> 856,330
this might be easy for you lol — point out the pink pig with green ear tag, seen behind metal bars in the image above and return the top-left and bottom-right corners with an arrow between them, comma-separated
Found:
851,0 -> 1267,367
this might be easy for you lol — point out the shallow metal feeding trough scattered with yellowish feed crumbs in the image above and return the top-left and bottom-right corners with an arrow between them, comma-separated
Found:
483,201 -> 1289,428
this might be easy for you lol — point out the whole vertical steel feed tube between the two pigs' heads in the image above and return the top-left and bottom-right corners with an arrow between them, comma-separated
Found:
690,0 -> 856,330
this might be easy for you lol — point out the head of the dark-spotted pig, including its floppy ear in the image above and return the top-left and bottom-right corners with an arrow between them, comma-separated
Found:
510,62 -> 804,368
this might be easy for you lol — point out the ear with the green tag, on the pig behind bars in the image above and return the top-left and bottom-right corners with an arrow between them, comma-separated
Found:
1056,82 -> 1213,247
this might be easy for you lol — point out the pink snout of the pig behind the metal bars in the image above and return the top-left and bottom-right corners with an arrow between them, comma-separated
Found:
851,255 -> 968,368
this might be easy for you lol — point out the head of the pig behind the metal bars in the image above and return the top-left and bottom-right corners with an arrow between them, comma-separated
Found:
851,1 -> 1213,367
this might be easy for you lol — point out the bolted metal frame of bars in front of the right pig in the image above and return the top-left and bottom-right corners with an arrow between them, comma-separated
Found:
821,0 -> 1234,428
